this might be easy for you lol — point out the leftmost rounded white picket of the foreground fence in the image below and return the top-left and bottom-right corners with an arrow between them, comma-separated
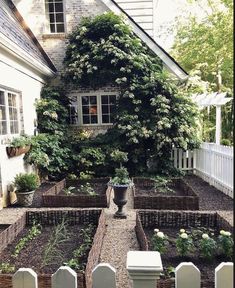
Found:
12,268 -> 38,288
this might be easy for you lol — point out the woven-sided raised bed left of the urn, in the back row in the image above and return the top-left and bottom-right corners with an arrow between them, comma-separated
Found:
42,178 -> 111,208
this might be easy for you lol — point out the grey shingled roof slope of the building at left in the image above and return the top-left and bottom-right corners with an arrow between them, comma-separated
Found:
0,0 -> 56,73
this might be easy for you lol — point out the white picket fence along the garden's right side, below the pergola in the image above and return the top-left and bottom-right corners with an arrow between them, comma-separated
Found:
172,143 -> 233,198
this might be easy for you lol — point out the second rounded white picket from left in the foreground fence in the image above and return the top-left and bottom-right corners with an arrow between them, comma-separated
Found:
51,266 -> 77,288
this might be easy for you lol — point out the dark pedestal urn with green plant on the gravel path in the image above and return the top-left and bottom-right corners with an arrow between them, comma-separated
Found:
109,167 -> 133,218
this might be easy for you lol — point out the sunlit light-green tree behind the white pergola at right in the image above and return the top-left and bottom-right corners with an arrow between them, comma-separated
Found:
172,0 -> 233,140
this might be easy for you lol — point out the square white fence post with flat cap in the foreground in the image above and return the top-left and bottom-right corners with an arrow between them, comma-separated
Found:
127,251 -> 163,288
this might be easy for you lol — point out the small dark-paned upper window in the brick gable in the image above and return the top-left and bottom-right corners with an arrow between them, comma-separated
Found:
46,0 -> 65,33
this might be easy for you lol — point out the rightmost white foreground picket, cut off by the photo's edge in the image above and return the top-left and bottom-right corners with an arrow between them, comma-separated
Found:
215,262 -> 234,288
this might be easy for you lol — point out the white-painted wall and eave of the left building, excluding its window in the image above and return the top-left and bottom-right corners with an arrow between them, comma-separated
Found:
0,48 -> 43,209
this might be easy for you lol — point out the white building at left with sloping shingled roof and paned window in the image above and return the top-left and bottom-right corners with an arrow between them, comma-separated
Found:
0,0 -> 56,209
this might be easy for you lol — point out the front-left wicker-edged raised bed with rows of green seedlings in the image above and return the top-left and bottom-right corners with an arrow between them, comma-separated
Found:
0,209 -> 106,288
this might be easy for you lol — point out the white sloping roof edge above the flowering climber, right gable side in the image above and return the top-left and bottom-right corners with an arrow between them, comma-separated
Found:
101,0 -> 188,80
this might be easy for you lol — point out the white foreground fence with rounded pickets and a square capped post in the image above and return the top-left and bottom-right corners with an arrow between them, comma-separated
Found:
9,251 -> 233,288
